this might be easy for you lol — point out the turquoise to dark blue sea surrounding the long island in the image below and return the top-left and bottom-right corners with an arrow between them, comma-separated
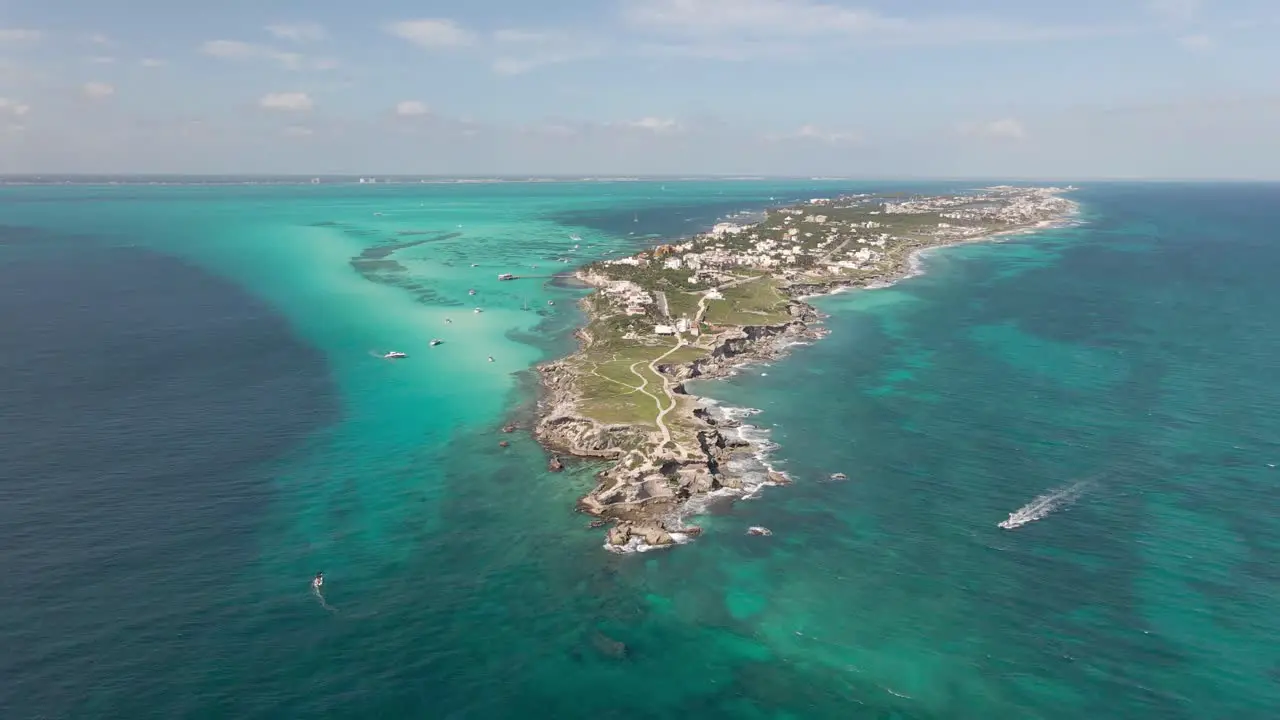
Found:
0,181 -> 1280,720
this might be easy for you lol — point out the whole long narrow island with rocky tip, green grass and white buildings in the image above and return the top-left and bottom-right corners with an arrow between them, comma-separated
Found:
534,186 -> 1076,551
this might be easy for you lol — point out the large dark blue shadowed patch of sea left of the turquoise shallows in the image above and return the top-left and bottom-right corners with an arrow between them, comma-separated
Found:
0,239 -> 338,717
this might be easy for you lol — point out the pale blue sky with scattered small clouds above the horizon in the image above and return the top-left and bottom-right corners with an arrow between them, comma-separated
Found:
0,0 -> 1280,178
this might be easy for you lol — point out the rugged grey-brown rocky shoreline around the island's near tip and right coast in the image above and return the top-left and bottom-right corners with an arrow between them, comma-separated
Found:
534,190 -> 1080,552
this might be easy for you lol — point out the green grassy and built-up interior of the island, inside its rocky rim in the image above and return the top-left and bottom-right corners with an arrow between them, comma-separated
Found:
571,185 -> 1070,430
